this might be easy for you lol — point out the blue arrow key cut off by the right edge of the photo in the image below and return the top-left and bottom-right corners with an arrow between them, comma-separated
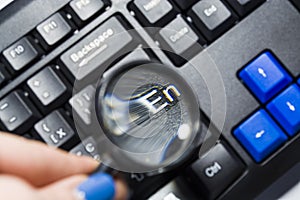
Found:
267,84 -> 300,136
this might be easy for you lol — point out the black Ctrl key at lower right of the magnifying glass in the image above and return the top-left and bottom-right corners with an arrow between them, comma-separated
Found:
187,143 -> 243,199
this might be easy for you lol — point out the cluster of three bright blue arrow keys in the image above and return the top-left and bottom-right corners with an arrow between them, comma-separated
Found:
233,51 -> 300,162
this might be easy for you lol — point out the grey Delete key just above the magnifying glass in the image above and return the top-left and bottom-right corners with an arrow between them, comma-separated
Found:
157,16 -> 203,65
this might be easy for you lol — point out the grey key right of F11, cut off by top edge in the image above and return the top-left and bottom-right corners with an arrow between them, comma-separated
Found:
70,0 -> 104,21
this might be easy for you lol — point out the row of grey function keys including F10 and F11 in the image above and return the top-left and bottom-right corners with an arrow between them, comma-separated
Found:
0,0 -> 109,85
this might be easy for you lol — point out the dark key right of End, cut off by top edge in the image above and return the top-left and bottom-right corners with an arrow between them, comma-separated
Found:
227,0 -> 265,17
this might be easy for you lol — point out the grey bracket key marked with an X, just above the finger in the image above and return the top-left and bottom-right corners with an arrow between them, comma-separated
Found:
34,110 -> 75,147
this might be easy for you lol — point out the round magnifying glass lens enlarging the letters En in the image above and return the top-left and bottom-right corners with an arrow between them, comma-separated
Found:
89,62 -> 201,174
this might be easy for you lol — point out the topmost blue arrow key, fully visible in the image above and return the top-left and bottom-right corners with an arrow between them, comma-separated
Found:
239,52 -> 292,103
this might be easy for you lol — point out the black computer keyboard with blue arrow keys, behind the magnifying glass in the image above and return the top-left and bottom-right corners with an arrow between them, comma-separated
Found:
0,0 -> 300,200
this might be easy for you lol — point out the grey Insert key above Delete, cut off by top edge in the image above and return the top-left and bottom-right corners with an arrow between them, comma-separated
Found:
133,0 -> 176,26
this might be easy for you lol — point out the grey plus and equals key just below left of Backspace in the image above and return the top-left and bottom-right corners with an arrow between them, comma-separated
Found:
27,67 -> 68,111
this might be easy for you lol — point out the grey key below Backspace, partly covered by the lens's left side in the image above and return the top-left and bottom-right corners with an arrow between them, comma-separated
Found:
69,85 -> 95,125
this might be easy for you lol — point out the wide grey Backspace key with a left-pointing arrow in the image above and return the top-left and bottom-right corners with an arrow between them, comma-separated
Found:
60,17 -> 133,81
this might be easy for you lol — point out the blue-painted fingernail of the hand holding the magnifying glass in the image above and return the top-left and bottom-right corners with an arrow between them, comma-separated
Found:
76,173 -> 115,200
